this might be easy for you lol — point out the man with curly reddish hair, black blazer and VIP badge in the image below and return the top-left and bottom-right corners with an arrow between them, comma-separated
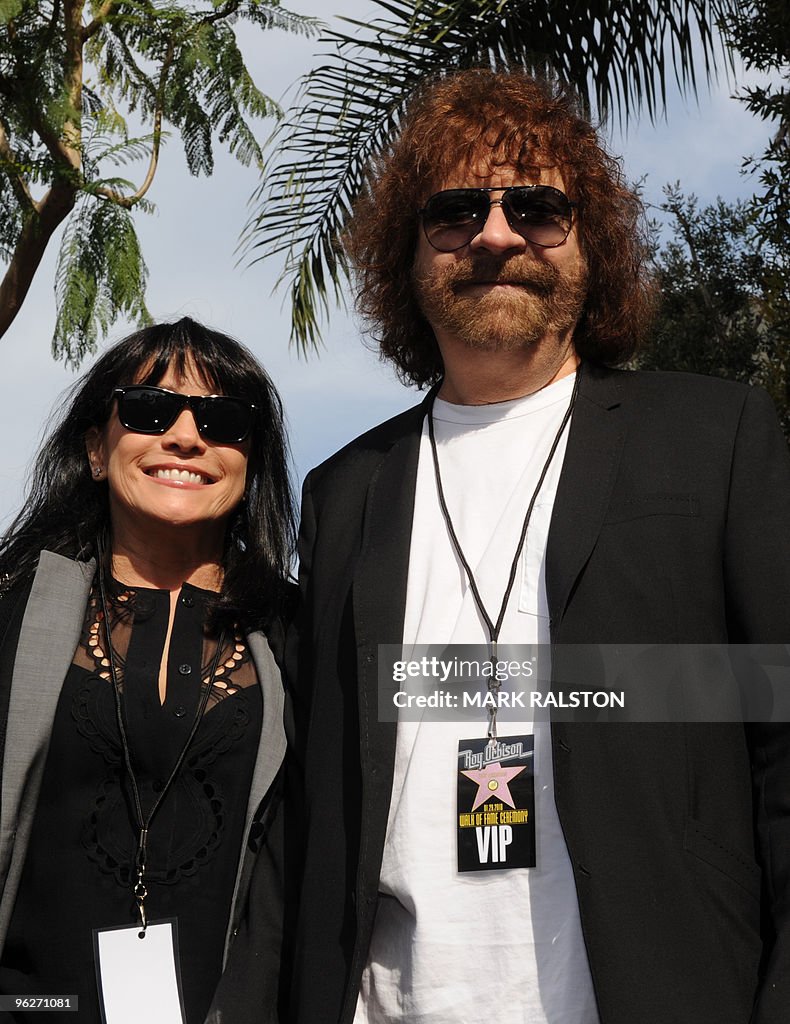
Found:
243,71 -> 790,1024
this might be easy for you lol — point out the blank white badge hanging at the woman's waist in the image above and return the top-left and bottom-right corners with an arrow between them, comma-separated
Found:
93,919 -> 184,1024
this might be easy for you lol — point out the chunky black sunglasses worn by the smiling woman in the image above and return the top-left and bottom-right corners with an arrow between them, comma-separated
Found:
113,384 -> 255,444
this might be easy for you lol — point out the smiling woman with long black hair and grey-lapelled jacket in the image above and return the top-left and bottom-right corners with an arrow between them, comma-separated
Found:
0,318 -> 293,1024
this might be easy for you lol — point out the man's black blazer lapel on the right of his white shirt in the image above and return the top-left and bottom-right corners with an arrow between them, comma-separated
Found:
546,364 -> 625,639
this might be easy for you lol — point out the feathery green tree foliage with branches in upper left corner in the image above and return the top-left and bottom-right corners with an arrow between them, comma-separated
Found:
0,0 -> 320,365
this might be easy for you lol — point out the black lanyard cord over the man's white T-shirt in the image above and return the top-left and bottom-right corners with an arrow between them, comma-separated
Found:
427,372 -> 582,742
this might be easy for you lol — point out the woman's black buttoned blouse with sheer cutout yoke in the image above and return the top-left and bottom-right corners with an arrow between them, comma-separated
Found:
0,584 -> 262,1024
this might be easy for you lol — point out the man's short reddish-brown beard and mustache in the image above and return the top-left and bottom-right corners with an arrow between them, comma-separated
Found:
414,254 -> 587,351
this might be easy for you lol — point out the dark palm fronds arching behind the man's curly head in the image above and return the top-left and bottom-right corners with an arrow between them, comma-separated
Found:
241,0 -> 736,349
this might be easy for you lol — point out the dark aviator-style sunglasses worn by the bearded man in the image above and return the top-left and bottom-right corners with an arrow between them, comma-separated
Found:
419,185 -> 577,253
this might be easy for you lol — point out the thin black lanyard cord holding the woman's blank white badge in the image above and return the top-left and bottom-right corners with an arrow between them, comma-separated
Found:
97,540 -> 225,938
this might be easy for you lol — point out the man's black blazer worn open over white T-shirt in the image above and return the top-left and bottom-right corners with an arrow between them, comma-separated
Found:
288,366 -> 790,1024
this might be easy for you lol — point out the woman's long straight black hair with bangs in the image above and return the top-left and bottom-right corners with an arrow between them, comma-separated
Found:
0,317 -> 295,629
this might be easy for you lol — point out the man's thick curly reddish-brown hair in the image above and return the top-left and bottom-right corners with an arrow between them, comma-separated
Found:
343,70 -> 654,386
